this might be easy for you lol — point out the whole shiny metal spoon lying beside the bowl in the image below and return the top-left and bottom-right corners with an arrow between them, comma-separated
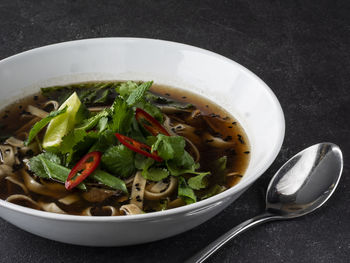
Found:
186,143 -> 343,263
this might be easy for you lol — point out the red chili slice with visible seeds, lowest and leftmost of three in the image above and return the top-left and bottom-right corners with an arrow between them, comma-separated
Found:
65,152 -> 102,190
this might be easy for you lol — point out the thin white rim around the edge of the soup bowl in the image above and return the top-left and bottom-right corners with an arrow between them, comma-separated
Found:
0,37 -> 285,223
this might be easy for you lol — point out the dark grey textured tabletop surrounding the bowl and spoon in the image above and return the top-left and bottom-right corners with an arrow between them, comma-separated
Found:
0,0 -> 350,263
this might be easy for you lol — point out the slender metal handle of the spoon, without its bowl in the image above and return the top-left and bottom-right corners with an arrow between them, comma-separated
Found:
185,212 -> 276,263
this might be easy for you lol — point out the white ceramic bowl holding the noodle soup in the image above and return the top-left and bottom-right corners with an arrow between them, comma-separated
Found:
0,38 -> 285,246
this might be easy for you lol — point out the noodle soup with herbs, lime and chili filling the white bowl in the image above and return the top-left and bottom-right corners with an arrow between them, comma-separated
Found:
0,82 -> 250,216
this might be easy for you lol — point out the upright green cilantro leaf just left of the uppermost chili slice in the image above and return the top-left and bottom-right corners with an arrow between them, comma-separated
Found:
110,97 -> 134,134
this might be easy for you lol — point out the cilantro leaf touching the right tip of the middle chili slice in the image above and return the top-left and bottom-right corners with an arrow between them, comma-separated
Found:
152,134 -> 186,160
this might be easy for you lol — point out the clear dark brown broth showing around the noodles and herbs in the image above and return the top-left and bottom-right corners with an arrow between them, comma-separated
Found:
0,83 -> 250,215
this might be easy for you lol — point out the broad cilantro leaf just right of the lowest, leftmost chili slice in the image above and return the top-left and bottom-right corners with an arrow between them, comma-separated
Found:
101,145 -> 135,178
